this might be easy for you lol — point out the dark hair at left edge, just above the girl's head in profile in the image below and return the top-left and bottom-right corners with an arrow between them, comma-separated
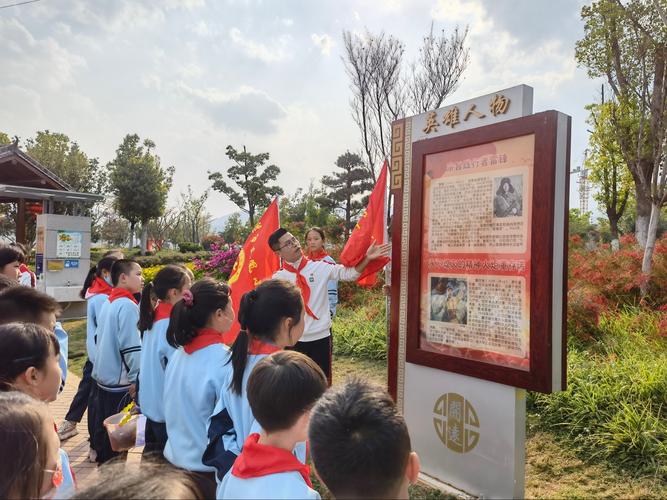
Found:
0,286 -> 61,324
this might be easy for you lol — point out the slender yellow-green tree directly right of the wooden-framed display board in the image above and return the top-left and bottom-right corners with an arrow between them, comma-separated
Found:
584,97 -> 633,249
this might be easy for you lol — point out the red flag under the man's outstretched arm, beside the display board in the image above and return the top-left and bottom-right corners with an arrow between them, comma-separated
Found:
340,160 -> 389,287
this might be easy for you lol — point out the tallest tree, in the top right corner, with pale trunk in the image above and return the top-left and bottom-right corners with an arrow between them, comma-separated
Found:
576,0 -> 667,293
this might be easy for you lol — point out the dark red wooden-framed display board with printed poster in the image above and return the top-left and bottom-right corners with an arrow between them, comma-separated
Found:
406,111 -> 569,392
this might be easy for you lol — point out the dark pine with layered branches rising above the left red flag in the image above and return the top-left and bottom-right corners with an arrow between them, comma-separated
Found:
208,146 -> 283,227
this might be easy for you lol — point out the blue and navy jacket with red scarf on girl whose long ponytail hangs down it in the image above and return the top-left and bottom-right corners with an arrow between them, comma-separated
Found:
202,340 -> 280,481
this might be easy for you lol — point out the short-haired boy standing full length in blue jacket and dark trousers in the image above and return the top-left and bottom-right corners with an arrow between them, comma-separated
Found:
88,259 -> 144,464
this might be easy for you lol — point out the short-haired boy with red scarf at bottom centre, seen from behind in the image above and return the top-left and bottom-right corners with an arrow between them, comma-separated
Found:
216,351 -> 327,499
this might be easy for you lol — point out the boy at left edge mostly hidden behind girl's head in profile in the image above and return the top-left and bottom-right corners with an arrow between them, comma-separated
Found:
0,285 -> 69,390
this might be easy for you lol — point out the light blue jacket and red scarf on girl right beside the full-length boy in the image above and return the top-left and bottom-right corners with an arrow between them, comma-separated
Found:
139,302 -> 176,423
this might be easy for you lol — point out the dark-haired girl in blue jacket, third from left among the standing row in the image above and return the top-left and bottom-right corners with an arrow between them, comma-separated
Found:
163,278 -> 234,498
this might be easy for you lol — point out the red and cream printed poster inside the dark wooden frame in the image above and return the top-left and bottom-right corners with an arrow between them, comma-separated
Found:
420,134 -> 535,371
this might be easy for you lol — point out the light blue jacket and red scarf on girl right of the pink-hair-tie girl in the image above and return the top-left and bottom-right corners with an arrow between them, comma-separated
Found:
164,329 -> 230,472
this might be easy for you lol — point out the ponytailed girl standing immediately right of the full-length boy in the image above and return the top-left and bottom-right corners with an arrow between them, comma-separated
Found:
138,265 -> 192,457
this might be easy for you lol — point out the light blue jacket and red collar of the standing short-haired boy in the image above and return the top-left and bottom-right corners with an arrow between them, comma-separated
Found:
92,288 -> 141,392
